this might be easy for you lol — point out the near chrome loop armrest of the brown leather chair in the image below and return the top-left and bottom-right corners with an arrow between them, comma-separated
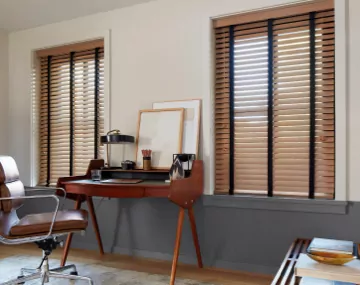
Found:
0,195 -> 60,244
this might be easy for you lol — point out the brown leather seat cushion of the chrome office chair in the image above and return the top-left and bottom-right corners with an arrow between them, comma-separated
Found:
10,207 -> 88,237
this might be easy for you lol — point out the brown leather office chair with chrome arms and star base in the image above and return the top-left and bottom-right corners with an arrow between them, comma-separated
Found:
0,156 -> 94,285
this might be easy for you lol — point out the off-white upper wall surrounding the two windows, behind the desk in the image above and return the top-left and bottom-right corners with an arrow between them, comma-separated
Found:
9,0 -> 352,197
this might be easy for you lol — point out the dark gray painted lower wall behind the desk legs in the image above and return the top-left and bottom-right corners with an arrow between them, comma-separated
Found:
21,197 -> 360,274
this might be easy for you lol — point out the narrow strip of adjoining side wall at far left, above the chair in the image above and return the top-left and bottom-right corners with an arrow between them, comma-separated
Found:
0,30 -> 9,154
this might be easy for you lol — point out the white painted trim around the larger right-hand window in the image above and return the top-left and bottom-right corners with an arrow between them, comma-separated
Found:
211,0 -> 349,202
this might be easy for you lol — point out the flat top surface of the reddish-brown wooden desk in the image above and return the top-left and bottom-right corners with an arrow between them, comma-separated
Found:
62,179 -> 170,187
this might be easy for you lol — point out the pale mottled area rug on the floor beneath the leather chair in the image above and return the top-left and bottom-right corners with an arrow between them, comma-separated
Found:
0,255 -> 214,285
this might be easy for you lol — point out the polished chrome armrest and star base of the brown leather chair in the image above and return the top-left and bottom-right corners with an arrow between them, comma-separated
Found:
0,187 -> 94,285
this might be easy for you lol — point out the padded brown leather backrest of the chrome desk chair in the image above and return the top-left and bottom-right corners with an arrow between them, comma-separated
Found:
0,156 -> 25,213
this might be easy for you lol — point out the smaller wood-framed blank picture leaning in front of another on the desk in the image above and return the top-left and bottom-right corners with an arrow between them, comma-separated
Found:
135,108 -> 185,170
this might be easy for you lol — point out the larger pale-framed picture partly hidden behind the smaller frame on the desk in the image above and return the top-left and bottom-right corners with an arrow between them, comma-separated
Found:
153,99 -> 202,159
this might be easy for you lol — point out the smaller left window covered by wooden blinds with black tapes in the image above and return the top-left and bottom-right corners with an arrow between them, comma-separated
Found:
38,41 -> 104,185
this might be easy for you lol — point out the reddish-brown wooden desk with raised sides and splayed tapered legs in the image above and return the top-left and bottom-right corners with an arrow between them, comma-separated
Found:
58,160 -> 204,285
